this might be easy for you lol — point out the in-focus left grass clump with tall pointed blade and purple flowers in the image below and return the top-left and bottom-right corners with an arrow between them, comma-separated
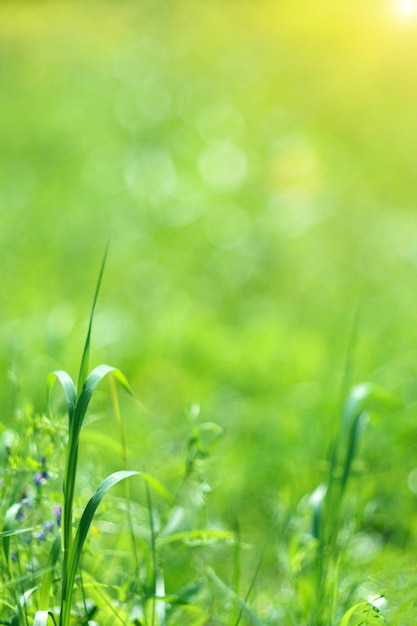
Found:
0,253 -> 234,626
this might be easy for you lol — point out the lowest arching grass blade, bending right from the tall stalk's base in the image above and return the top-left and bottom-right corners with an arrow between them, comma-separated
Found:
60,471 -> 139,626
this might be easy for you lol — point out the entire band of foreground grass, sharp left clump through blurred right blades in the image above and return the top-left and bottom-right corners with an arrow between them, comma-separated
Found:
0,252 -> 404,626
